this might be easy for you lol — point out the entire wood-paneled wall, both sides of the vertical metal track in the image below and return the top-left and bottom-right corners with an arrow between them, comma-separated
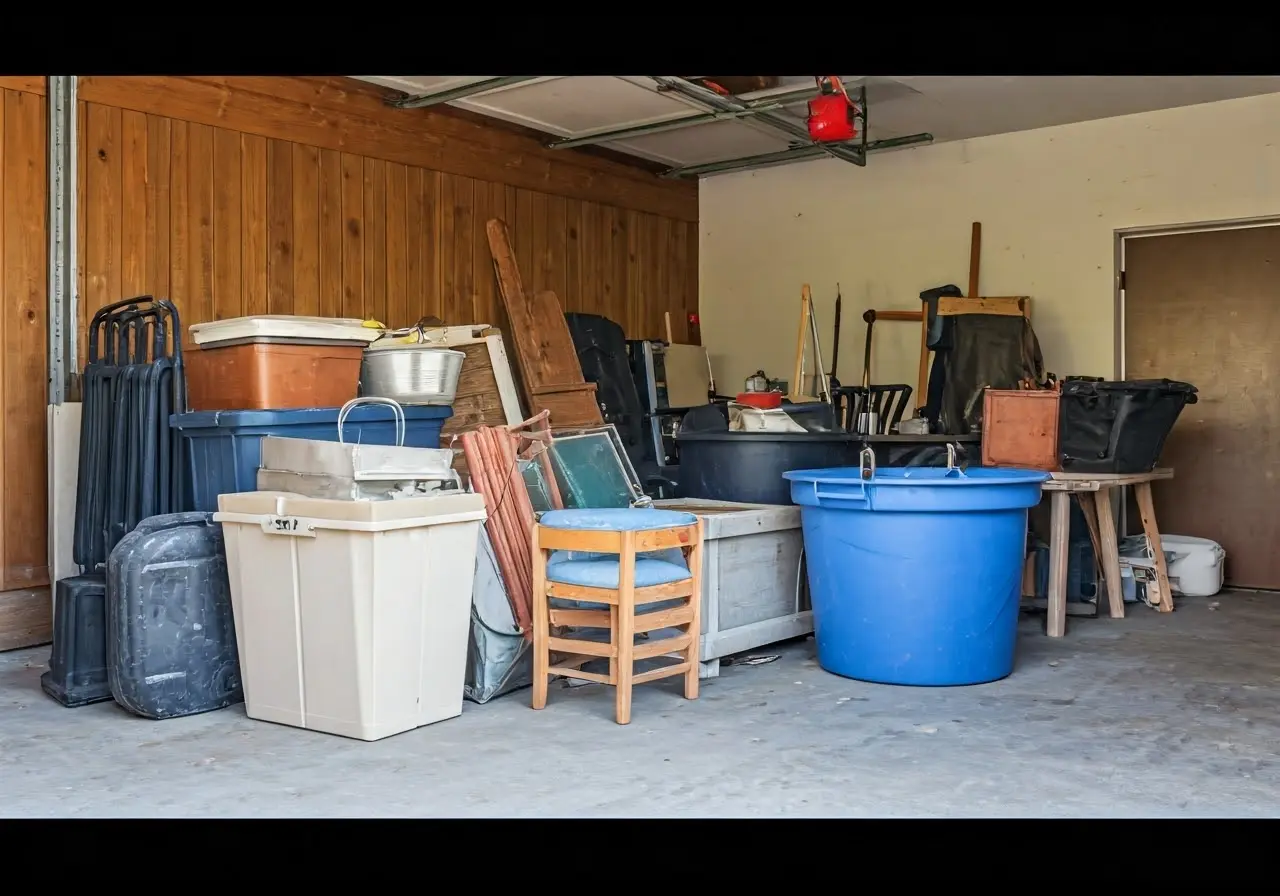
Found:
0,76 -> 698,650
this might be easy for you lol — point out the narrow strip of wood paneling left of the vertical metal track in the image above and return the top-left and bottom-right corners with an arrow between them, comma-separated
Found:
0,91 -> 50,593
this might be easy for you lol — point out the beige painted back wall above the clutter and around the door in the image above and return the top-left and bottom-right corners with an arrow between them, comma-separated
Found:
700,93 -> 1280,393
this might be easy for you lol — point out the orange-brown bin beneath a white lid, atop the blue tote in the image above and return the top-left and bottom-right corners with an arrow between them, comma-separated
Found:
183,342 -> 365,411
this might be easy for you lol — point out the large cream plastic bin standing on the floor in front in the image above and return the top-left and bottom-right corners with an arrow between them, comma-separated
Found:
214,492 -> 485,741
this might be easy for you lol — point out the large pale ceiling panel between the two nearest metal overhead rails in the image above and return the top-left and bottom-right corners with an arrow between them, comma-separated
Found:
457,76 -> 696,137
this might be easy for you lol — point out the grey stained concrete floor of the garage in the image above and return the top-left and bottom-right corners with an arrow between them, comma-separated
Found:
0,594 -> 1280,818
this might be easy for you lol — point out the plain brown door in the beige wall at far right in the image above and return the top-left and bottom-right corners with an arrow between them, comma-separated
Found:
1120,224 -> 1280,590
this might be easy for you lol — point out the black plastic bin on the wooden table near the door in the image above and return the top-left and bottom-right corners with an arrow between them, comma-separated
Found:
1059,379 -> 1197,474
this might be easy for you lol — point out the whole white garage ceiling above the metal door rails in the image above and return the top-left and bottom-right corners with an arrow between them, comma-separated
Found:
355,76 -> 1280,177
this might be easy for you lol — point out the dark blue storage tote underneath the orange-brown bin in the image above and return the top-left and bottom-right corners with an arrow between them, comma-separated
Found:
169,404 -> 453,512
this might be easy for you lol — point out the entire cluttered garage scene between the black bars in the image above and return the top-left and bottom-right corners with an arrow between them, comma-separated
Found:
0,76 -> 1280,817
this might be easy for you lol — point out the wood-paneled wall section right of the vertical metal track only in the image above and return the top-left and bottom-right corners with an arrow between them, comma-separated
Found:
79,78 -> 698,350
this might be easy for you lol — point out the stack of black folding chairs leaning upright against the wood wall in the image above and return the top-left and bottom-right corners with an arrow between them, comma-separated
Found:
72,296 -> 187,572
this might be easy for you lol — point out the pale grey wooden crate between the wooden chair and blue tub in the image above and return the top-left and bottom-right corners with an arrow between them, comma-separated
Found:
653,498 -> 813,678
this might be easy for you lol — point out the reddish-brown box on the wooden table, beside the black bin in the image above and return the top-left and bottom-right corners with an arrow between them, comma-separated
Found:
982,389 -> 1062,472
